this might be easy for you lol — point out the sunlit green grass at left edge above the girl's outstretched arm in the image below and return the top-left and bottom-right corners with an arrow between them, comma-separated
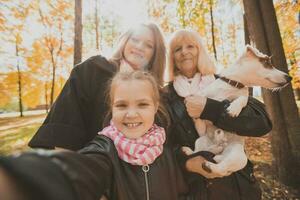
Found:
0,124 -> 40,155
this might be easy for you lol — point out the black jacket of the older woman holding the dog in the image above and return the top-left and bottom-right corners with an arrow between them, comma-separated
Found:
163,83 -> 272,200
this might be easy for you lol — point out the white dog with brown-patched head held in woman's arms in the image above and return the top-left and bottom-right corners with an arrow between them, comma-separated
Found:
183,45 -> 291,176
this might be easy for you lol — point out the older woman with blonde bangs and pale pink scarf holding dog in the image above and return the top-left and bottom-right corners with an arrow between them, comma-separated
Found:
166,30 -> 272,200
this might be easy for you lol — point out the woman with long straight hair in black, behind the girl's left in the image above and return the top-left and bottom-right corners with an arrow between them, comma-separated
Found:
29,23 -> 166,150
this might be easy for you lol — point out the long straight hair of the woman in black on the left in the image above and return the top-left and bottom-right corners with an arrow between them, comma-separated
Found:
109,23 -> 166,86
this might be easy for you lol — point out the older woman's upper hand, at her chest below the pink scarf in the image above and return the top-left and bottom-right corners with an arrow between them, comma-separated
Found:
185,96 -> 206,118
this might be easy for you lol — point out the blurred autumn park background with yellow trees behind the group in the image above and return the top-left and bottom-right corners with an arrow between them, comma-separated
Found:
0,0 -> 300,199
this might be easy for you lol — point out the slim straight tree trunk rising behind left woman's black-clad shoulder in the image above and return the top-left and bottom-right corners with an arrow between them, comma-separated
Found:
74,0 -> 82,66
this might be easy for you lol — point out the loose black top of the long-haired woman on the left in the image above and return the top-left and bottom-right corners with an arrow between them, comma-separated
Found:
29,56 -> 117,150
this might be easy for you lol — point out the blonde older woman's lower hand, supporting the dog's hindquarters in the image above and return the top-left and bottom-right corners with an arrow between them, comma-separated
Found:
185,156 -> 227,179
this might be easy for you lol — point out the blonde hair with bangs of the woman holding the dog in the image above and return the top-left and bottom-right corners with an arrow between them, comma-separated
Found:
168,30 -> 216,81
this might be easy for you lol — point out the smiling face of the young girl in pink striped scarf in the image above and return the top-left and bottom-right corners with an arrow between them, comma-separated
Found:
111,80 -> 158,139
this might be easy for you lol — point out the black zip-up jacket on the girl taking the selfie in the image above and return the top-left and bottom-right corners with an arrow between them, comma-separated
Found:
0,136 -> 191,200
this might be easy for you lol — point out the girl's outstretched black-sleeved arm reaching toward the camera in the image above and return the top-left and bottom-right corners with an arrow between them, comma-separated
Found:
0,147 -> 112,200
